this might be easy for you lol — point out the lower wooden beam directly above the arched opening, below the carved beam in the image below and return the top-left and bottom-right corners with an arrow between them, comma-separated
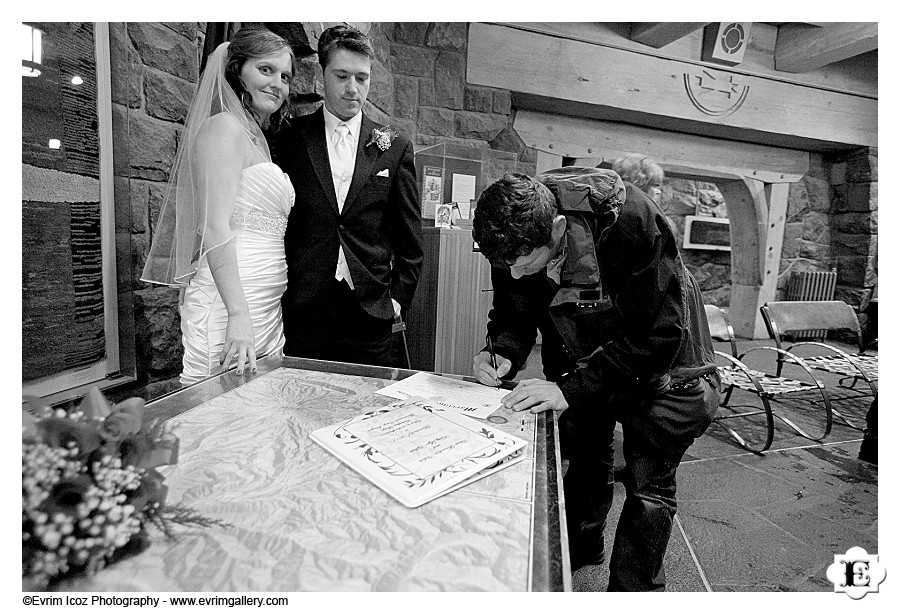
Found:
513,110 -> 809,183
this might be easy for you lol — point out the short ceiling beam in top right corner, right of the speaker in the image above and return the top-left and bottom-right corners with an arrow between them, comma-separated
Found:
775,22 -> 878,73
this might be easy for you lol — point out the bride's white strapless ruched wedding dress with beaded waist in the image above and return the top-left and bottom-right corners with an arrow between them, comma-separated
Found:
180,162 -> 294,385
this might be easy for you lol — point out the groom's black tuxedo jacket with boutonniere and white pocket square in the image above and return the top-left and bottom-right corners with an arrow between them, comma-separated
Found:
272,108 -> 422,328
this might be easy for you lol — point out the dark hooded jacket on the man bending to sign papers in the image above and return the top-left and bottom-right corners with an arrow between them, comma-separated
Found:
488,167 -> 716,406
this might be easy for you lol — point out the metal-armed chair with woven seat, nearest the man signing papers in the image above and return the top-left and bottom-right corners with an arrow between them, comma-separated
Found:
704,305 -> 832,454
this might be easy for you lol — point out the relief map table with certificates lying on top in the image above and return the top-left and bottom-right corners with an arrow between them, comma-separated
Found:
66,357 -> 571,592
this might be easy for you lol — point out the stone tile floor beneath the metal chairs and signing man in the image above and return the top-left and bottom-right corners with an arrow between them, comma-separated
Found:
521,340 -> 890,596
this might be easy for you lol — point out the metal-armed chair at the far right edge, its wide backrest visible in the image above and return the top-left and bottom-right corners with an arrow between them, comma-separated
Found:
759,301 -> 878,430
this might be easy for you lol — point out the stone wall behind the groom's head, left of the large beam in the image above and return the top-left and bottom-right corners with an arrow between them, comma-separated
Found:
274,22 -> 537,172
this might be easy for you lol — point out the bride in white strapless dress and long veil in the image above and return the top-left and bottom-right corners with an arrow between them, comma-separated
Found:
141,28 -> 294,385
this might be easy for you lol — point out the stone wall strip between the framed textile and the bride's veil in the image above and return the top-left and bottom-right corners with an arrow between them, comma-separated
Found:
110,23 -> 206,398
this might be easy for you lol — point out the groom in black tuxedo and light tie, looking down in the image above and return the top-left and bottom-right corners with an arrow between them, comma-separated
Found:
274,26 -> 422,366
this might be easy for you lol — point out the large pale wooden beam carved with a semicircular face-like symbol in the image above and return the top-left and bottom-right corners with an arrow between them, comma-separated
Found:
467,23 -> 878,149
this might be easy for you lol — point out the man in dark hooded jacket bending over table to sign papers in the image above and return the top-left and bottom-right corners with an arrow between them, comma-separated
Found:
473,167 -> 719,591
